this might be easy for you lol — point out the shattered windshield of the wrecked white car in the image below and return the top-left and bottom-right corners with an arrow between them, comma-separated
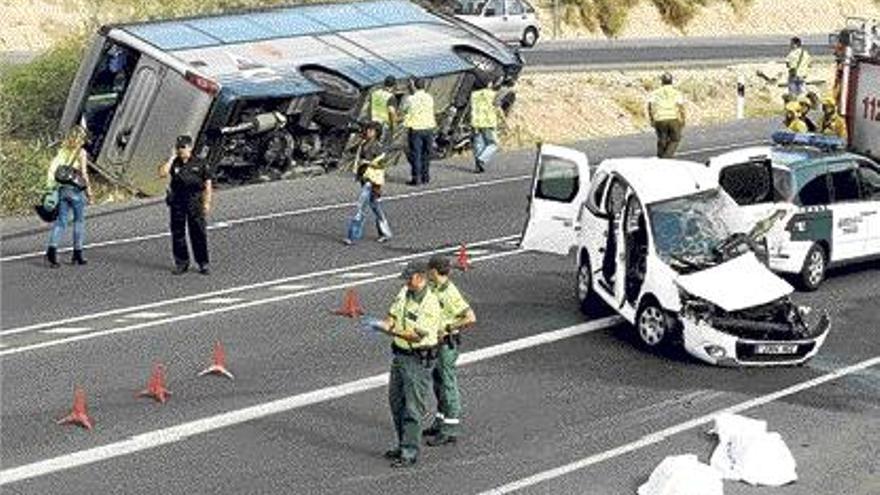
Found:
648,189 -> 742,272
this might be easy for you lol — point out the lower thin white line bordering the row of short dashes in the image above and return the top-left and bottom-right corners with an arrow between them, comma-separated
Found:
0,251 -> 525,357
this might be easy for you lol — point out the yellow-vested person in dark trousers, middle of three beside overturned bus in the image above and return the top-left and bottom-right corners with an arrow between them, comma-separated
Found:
403,78 -> 437,186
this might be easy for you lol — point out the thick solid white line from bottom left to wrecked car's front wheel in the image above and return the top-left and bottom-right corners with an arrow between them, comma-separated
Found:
0,316 -> 622,486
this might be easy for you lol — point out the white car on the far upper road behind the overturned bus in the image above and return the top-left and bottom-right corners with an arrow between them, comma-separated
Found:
455,0 -> 541,47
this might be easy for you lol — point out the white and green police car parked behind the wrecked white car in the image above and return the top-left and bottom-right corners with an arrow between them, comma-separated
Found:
709,132 -> 880,290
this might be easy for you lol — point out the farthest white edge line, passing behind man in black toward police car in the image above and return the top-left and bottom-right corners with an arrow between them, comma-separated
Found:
0,140 -> 767,262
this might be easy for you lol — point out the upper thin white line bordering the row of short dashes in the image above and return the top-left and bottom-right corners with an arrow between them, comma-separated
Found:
0,236 -> 516,336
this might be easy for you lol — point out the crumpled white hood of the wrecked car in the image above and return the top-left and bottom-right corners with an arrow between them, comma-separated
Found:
675,252 -> 794,311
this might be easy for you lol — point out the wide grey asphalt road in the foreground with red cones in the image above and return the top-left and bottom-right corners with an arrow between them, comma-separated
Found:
0,121 -> 880,495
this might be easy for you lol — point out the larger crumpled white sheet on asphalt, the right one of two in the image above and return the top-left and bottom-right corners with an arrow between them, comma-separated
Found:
709,414 -> 797,486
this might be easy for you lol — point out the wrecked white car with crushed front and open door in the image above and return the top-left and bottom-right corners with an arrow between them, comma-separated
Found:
522,145 -> 830,366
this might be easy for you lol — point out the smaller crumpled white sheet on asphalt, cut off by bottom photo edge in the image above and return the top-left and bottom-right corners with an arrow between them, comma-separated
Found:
638,454 -> 724,495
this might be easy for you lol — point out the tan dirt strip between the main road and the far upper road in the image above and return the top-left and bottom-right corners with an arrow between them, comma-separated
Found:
504,64 -> 834,147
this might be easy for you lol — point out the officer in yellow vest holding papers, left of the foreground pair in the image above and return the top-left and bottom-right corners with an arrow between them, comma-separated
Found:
378,261 -> 443,468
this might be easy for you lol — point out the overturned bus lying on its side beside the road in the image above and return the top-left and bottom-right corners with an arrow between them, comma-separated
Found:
61,0 -> 523,195
